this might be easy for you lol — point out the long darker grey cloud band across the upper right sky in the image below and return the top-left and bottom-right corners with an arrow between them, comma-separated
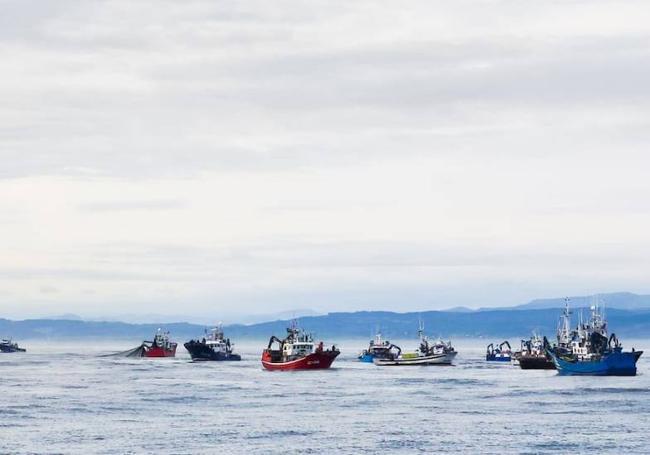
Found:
223,37 -> 650,110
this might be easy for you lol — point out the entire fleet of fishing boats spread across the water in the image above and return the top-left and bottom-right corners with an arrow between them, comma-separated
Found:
0,299 -> 643,376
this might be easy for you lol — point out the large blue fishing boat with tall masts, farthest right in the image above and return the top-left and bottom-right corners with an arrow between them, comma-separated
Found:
546,299 -> 643,376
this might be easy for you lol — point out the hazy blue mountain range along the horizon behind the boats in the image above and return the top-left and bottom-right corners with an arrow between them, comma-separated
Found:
0,293 -> 650,341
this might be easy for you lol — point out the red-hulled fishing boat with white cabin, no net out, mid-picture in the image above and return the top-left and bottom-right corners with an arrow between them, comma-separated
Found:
262,321 -> 341,371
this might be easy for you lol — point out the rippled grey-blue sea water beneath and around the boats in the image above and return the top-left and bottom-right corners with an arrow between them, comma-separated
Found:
0,340 -> 650,454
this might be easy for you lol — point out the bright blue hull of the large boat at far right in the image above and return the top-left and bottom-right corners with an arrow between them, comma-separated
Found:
551,351 -> 643,376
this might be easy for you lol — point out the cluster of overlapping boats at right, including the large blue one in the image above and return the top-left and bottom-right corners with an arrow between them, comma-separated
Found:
485,299 -> 643,376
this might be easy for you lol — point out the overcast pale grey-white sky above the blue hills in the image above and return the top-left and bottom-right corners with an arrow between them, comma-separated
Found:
0,0 -> 650,320
